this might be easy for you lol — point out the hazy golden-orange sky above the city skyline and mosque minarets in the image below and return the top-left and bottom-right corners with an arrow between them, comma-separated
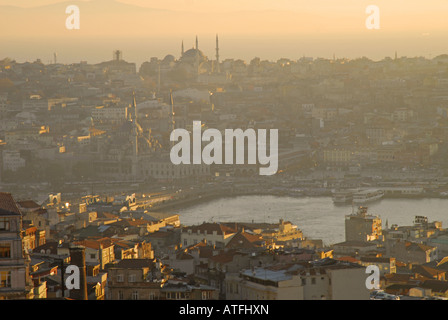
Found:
0,0 -> 448,63
